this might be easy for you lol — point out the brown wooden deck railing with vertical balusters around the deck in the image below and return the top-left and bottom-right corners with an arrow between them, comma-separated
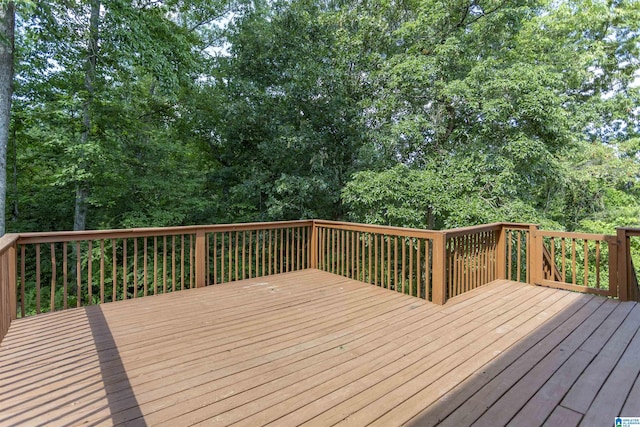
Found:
0,220 -> 640,340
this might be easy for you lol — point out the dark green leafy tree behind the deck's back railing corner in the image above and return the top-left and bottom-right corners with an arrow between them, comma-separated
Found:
210,0 -> 370,221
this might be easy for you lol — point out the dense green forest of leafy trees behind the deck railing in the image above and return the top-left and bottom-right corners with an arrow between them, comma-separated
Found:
0,0 -> 640,234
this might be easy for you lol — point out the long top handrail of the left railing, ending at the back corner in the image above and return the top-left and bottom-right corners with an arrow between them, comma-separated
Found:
16,220 -> 313,244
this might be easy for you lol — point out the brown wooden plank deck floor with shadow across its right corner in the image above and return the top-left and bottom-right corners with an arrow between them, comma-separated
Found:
0,270 -> 640,426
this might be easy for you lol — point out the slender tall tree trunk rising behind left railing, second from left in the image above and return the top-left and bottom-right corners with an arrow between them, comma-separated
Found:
73,0 -> 100,230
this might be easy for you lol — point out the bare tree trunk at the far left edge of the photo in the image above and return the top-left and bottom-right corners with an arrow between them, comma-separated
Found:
0,1 -> 15,236
